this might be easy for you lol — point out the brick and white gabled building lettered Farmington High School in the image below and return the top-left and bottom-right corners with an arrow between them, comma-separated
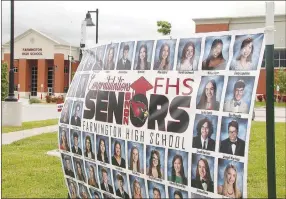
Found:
2,29 -> 79,98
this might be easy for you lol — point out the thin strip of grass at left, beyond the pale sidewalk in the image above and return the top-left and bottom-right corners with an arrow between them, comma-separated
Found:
2,119 -> 59,133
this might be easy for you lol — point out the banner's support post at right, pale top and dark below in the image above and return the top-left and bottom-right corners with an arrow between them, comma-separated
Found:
265,1 -> 276,198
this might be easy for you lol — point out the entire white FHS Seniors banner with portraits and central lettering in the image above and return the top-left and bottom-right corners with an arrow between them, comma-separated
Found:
59,29 -> 265,198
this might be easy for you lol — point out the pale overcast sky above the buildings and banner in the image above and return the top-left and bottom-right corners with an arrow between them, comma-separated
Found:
2,1 -> 286,46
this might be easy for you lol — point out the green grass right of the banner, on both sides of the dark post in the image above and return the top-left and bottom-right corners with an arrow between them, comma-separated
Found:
248,122 -> 286,198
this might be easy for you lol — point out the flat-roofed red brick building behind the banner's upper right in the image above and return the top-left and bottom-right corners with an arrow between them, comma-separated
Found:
193,15 -> 286,94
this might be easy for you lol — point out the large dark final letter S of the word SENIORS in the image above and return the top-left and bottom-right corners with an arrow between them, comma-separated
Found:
166,96 -> 191,133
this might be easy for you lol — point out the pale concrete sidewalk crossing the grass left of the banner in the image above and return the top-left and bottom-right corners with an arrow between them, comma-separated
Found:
2,125 -> 59,145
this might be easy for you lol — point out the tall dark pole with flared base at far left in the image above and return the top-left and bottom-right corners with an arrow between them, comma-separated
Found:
5,0 -> 18,102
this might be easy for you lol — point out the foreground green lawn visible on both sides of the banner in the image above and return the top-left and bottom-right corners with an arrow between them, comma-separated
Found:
2,122 -> 286,198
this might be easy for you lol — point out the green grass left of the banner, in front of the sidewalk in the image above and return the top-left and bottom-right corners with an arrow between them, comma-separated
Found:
2,133 -> 68,198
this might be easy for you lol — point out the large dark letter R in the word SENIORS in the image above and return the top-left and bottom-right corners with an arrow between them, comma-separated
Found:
148,94 -> 169,131
